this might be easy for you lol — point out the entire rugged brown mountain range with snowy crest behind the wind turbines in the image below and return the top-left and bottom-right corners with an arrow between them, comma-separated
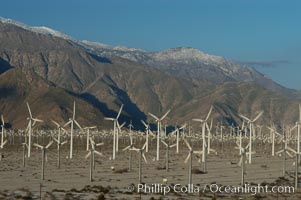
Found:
0,19 -> 297,128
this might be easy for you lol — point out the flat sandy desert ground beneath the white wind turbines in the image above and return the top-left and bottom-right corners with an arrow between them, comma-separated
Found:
0,134 -> 301,199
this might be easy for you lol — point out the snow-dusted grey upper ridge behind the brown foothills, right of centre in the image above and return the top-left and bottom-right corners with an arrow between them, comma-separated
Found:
78,41 -> 301,99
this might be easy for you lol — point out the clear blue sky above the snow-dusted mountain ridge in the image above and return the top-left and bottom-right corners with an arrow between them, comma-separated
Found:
0,0 -> 301,89
